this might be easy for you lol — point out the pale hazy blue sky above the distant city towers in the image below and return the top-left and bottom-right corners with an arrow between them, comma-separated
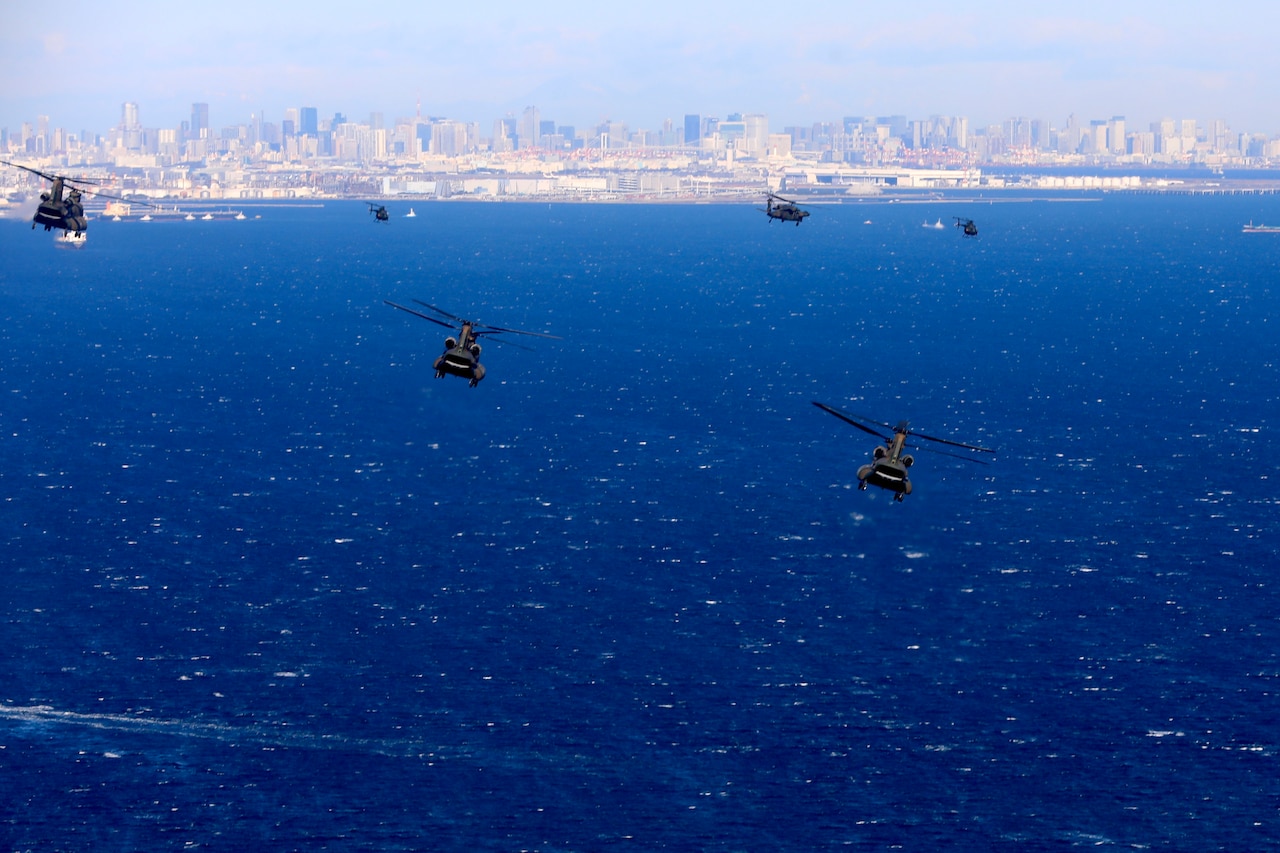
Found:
0,0 -> 1280,134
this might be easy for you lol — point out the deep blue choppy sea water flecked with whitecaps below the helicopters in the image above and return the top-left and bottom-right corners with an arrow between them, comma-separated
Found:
0,195 -> 1280,850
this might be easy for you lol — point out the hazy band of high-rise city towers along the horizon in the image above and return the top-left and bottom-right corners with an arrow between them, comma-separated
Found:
0,102 -> 1280,165
